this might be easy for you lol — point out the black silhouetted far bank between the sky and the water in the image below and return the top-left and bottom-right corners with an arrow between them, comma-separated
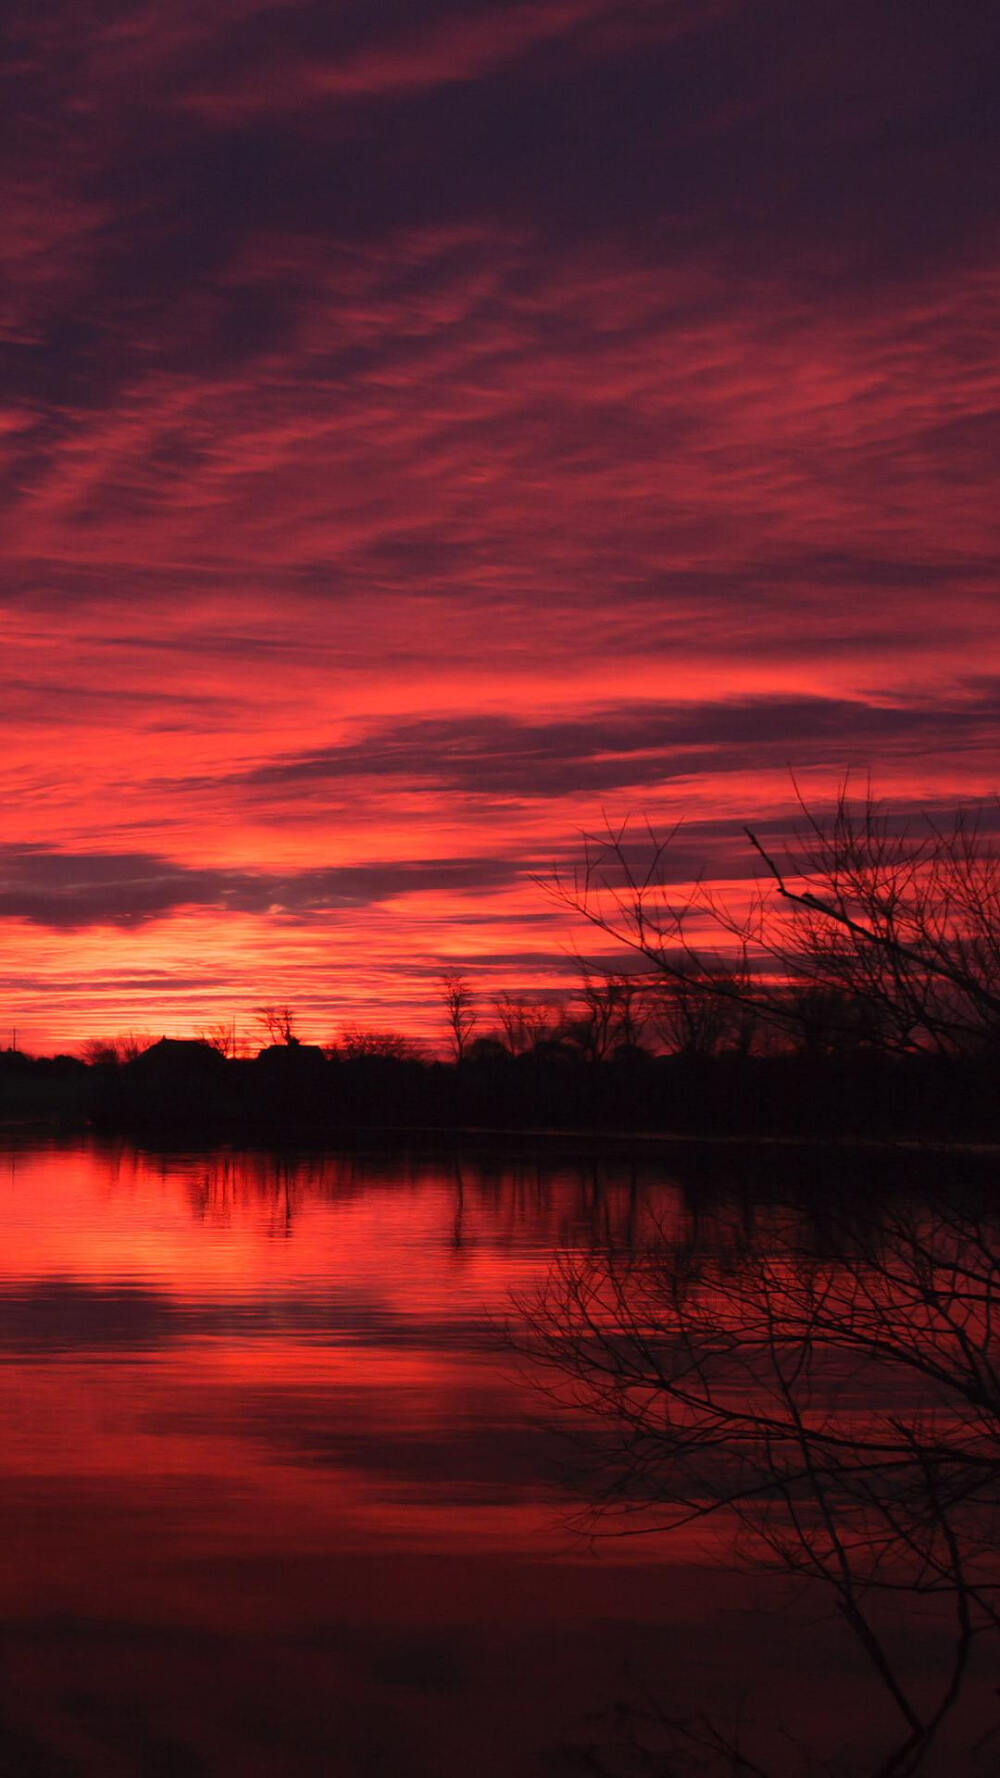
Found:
0,1040 -> 1000,1143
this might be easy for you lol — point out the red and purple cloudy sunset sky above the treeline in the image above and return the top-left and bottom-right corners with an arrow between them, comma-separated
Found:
0,0 -> 1000,1049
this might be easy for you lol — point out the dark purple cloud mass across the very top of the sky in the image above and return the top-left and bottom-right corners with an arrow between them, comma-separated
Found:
0,0 -> 1000,419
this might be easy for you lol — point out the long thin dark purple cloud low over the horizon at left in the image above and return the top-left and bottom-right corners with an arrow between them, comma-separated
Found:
0,846 -> 516,930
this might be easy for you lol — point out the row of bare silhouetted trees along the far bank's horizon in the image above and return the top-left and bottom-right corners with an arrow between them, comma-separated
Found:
1,784 -> 1000,1127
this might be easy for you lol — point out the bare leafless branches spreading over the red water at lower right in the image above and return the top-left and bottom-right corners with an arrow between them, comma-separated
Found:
521,1191 -> 1000,1774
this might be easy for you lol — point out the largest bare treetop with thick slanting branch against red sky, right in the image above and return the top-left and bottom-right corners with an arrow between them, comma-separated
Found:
548,782 -> 1000,1053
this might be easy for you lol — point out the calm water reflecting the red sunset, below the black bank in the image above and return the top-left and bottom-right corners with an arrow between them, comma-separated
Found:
0,1141 -> 993,1778
